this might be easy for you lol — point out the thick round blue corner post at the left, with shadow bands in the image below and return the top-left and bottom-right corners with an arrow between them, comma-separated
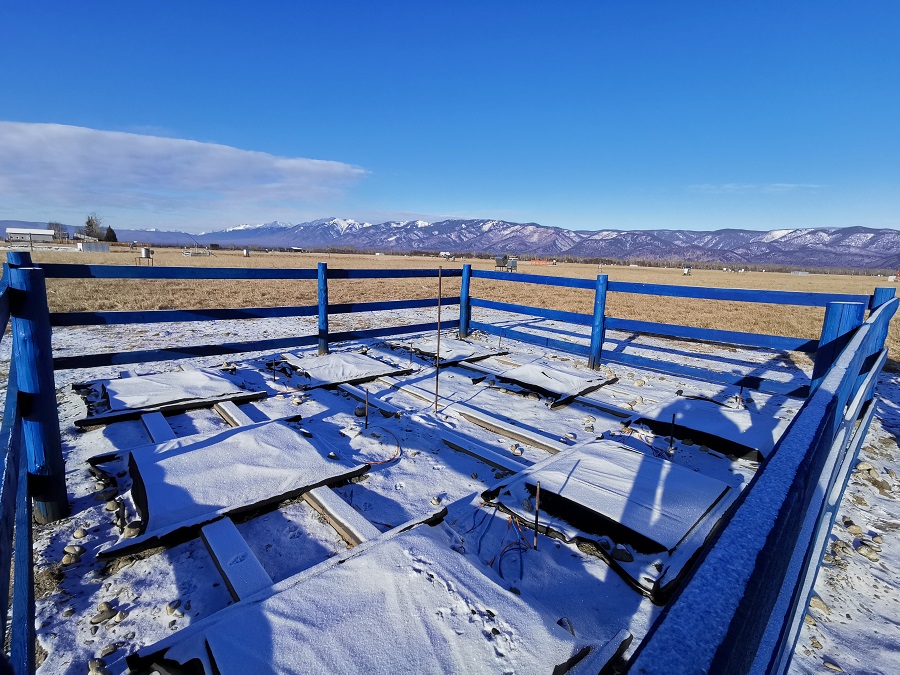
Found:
7,253 -> 69,523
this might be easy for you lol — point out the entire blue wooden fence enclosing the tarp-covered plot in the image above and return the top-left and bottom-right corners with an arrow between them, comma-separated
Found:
0,254 -> 897,673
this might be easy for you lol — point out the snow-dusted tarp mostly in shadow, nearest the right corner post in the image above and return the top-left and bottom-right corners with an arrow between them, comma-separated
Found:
636,398 -> 790,457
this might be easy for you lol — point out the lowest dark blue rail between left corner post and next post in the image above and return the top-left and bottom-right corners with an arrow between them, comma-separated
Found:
53,335 -> 318,370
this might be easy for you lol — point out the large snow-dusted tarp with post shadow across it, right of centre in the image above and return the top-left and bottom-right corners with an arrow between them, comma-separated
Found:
496,440 -> 729,551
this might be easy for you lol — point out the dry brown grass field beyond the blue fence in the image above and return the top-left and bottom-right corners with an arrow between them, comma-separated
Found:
26,247 -> 900,368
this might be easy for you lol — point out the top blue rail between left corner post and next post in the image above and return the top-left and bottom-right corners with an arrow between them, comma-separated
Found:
40,263 -> 316,280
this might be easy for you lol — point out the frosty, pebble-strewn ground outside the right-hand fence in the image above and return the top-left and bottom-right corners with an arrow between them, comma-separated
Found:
792,373 -> 900,675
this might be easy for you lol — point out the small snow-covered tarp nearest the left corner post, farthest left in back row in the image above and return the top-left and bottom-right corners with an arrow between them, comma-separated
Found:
102,370 -> 245,411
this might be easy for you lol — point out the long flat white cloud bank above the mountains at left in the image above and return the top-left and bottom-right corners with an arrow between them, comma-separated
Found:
0,121 -> 366,220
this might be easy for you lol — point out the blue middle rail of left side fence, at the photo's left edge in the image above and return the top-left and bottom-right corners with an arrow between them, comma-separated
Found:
0,359 -> 23,652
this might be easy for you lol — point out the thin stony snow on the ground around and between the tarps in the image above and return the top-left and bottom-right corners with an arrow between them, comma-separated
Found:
3,312 -> 900,673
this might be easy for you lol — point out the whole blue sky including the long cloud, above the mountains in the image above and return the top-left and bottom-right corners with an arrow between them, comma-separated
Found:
0,0 -> 900,231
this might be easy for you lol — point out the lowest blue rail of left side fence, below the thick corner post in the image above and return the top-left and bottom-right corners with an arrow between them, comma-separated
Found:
9,448 -> 35,673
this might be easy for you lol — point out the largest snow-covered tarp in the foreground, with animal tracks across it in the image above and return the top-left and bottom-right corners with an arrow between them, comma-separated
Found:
142,524 -> 594,675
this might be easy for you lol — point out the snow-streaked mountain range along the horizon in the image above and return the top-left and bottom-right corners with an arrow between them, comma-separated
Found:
0,218 -> 900,270
